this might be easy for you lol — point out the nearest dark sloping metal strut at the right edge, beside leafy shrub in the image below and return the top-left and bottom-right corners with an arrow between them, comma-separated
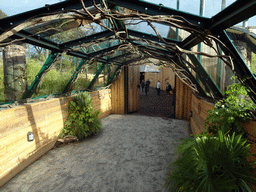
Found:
219,31 -> 256,103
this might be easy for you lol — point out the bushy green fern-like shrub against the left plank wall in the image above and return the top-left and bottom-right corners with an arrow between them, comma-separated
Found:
59,92 -> 101,139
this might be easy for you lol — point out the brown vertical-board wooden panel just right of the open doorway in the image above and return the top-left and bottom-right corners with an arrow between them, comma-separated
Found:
175,77 -> 192,120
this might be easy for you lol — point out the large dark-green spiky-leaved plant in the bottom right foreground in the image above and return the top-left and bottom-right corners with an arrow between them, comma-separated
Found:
165,131 -> 256,192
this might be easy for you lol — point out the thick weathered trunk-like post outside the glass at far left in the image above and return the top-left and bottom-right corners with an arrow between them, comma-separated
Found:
3,44 -> 27,102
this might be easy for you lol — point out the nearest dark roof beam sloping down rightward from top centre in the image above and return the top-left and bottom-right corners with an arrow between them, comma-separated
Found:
107,0 -> 210,26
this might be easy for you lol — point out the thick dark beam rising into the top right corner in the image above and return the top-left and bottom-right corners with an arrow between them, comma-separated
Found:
208,0 -> 256,33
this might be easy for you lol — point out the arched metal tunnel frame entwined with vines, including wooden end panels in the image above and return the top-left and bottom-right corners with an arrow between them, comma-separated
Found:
0,0 -> 256,188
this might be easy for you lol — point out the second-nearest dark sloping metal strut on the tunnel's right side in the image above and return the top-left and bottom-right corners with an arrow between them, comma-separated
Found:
184,54 -> 223,98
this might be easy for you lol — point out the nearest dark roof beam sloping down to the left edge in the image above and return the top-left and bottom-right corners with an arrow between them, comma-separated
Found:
0,0 -> 100,34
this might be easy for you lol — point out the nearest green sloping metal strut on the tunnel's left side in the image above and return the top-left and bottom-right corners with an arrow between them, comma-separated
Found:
22,53 -> 59,99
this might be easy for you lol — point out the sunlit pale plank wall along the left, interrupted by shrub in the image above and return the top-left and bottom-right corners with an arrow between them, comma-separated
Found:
0,89 -> 111,186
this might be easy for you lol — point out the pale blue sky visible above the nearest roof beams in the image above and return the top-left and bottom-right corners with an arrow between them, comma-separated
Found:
0,0 -> 256,26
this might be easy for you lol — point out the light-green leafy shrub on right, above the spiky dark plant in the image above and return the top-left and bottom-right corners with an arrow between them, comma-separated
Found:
205,79 -> 255,135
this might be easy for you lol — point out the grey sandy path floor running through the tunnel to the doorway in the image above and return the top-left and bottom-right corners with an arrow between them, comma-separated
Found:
0,115 -> 189,192
